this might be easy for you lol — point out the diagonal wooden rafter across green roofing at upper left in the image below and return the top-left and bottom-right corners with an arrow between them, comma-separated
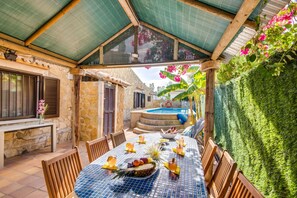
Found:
25,0 -> 80,46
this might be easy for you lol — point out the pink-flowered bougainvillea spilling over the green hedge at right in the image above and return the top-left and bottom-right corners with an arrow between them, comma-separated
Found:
218,1 -> 297,82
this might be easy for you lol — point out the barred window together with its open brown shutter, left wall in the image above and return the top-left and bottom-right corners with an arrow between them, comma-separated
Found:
0,70 -> 60,120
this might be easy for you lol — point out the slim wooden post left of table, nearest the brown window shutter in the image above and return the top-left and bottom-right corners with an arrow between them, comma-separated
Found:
72,75 -> 82,146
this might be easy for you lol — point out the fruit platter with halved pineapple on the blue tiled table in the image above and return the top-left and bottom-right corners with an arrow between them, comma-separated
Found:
114,157 -> 157,180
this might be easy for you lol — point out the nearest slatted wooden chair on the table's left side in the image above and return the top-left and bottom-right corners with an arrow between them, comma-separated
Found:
41,147 -> 82,198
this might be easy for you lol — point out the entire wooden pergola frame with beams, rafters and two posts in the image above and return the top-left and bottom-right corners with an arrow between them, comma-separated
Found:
0,0 -> 261,144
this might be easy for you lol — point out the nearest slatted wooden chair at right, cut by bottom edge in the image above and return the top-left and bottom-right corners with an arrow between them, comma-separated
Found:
226,171 -> 264,198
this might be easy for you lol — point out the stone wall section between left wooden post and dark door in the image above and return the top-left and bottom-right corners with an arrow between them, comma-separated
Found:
79,81 -> 101,141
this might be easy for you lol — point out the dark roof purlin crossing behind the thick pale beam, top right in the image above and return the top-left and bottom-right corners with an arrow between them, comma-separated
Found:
179,0 -> 257,29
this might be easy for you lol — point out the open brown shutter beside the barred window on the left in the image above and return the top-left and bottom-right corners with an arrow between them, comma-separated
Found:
40,77 -> 60,118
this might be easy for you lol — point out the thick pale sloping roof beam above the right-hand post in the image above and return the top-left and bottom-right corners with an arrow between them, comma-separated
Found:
211,0 -> 260,60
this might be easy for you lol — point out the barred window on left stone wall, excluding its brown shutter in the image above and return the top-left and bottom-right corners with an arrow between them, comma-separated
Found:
0,70 -> 38,120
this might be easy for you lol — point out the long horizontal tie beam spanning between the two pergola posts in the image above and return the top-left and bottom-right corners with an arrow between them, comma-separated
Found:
79,59 -> 209,69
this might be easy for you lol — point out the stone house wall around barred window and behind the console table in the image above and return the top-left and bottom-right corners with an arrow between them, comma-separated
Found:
0,60 -> 74,158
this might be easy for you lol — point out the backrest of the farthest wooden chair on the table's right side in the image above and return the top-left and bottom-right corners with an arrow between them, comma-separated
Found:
201,138 -> 217,174
